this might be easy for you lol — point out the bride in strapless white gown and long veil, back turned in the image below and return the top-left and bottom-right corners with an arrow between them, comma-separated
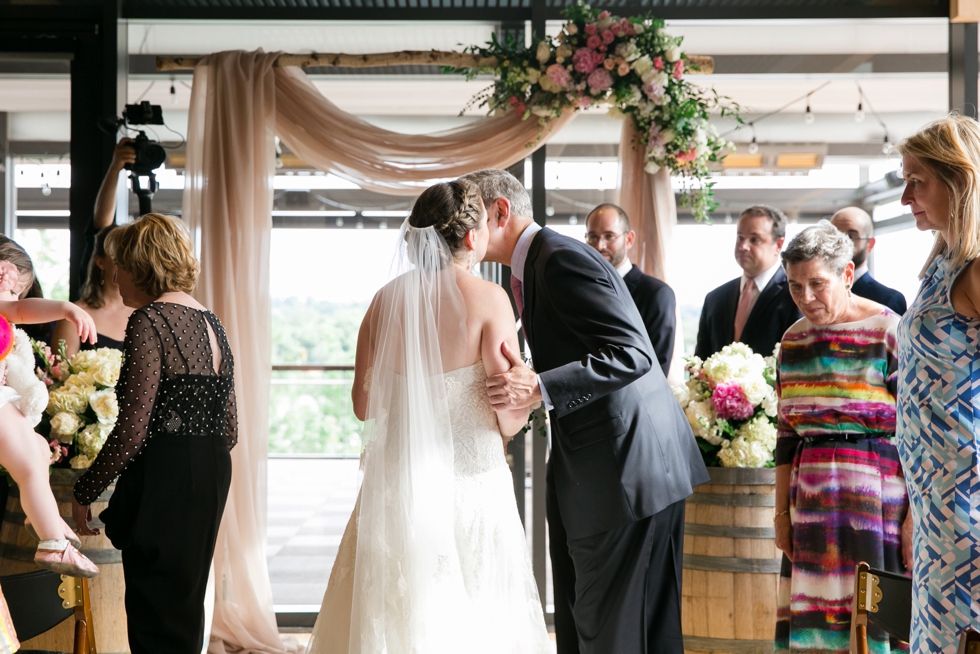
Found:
307,180 -> 551,654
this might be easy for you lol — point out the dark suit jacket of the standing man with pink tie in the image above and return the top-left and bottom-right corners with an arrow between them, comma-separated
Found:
694,268 -> 802,359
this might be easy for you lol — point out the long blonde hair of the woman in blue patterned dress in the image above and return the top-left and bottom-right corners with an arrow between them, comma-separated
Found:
895,115 -> 980,278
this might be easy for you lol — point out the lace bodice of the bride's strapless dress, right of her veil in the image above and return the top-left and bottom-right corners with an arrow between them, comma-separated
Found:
445,361 -> 507,477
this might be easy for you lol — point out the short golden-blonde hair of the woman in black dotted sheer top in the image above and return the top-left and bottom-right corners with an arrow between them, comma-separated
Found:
105,213 -> 201,298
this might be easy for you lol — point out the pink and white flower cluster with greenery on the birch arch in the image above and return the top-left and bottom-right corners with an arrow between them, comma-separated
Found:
450,2 -> 740,220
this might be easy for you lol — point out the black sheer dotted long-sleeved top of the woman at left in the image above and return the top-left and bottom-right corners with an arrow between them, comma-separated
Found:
75,302 -> 238,504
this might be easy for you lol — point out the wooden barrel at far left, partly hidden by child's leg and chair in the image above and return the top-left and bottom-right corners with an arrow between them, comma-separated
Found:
0,468 -> 129,654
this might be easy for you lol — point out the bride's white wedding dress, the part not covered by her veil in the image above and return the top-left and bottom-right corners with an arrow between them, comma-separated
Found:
307,362 -> 552,654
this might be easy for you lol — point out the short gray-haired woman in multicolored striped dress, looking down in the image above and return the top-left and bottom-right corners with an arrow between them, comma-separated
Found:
775,221 -> 908,654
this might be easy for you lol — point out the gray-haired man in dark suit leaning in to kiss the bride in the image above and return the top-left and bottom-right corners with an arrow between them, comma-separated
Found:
465,170 -> 708,654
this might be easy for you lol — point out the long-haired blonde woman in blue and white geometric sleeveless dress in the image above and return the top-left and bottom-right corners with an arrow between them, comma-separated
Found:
898,116 -> 980,654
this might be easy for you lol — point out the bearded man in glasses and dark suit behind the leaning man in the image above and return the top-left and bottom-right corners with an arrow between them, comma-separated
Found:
585,204 -> 677,377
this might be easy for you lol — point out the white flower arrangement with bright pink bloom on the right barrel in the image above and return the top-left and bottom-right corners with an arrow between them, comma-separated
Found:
673,343 -> 779,468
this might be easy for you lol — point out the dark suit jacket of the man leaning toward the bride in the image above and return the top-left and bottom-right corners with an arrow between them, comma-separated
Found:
523,228 -> 708,539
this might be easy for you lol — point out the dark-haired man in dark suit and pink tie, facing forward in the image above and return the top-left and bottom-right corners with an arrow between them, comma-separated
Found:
694,205 -> 800,359
